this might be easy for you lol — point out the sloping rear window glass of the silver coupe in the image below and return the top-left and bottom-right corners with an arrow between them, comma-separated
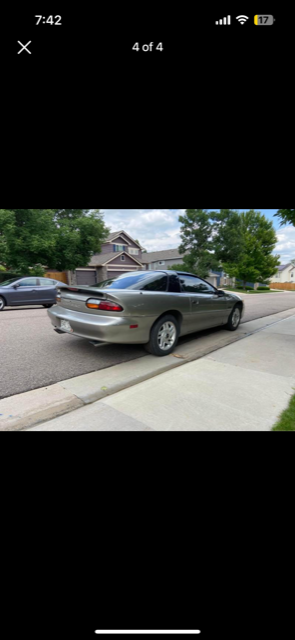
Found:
95,271 -> 168,291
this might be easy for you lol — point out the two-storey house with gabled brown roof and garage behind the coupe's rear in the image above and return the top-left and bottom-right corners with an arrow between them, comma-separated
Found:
68,230 -> 145,285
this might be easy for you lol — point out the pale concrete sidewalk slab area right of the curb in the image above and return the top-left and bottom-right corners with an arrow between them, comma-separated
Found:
26,309 -> 295,431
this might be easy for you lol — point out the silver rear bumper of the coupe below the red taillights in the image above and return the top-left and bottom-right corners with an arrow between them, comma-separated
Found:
47,305 -> 153,344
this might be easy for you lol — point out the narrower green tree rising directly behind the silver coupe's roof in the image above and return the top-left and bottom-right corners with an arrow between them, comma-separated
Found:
172,209 -> 219,278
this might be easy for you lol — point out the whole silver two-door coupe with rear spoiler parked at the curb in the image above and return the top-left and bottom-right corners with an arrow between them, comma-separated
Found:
47,270 -> 244,356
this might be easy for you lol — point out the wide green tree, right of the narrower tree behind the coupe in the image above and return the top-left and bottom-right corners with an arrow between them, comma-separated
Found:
223,209 -> 280,289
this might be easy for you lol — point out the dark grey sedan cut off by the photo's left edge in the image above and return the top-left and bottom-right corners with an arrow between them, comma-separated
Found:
0,277 -> 64,311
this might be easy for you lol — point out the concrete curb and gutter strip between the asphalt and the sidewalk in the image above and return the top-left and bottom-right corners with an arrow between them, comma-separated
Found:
0,309 -> 295,431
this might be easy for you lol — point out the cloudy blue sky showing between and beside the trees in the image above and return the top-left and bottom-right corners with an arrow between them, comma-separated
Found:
100,209 -> 295,264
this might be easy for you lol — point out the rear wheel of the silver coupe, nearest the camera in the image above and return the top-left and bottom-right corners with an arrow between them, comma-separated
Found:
145,315 -> 179,357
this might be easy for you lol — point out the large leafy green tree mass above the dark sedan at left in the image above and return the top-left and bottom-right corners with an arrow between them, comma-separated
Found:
0,209 -> 109,275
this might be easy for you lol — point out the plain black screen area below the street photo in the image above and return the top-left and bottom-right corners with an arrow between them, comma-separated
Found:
0,440 -> 294,640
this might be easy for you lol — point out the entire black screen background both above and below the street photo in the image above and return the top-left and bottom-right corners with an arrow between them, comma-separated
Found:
0,3 -> 294,640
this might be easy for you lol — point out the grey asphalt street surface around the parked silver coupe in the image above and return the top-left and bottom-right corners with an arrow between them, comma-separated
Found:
0,292 -> 295,399
